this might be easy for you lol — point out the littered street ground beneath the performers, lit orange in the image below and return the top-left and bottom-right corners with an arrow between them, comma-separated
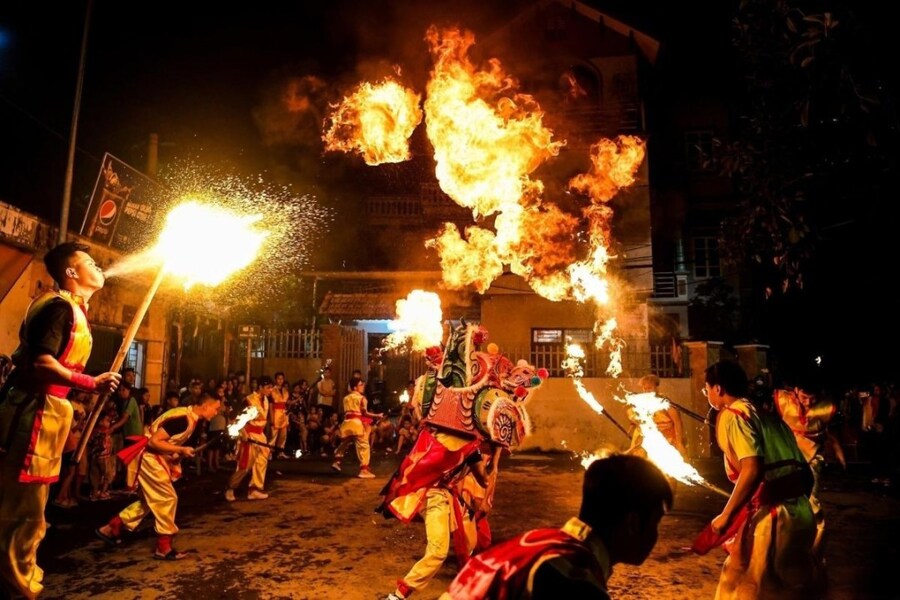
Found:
40,454 -> 900,600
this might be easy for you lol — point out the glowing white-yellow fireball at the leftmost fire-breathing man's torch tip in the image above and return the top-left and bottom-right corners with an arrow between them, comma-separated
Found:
152,202 -> 266,287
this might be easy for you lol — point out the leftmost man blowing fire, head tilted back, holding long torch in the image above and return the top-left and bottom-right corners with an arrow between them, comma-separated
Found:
0,242 -> 120,598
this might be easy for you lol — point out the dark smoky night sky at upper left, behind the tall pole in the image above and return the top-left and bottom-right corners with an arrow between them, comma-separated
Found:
0,0 -> 519,221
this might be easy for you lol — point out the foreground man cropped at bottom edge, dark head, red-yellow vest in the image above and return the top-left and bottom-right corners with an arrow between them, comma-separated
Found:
441,455 -> 672,600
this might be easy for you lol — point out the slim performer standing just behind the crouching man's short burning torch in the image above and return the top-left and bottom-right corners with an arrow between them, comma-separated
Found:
225,375 -> 272,502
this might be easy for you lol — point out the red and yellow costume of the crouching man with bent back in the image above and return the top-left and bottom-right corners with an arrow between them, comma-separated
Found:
118,406 -> 198,536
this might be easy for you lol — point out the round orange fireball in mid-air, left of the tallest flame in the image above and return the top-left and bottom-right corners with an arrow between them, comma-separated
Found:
322,78 -> 422,165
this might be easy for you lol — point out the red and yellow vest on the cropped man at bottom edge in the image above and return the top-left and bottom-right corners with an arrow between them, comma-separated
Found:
440,518 -> 612,600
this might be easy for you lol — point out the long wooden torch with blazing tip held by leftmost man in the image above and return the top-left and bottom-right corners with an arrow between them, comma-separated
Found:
72,202 -> 265,464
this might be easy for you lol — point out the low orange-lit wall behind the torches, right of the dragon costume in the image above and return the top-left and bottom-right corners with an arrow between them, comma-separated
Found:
521,378 -> 709,457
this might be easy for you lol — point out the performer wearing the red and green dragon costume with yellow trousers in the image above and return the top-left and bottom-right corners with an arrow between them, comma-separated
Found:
376,322 -> 541,600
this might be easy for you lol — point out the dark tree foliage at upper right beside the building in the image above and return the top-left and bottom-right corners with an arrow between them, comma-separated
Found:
717,0 -> 888,289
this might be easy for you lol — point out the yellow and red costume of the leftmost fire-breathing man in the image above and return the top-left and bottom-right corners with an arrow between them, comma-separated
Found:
0,290 -> 93,598
